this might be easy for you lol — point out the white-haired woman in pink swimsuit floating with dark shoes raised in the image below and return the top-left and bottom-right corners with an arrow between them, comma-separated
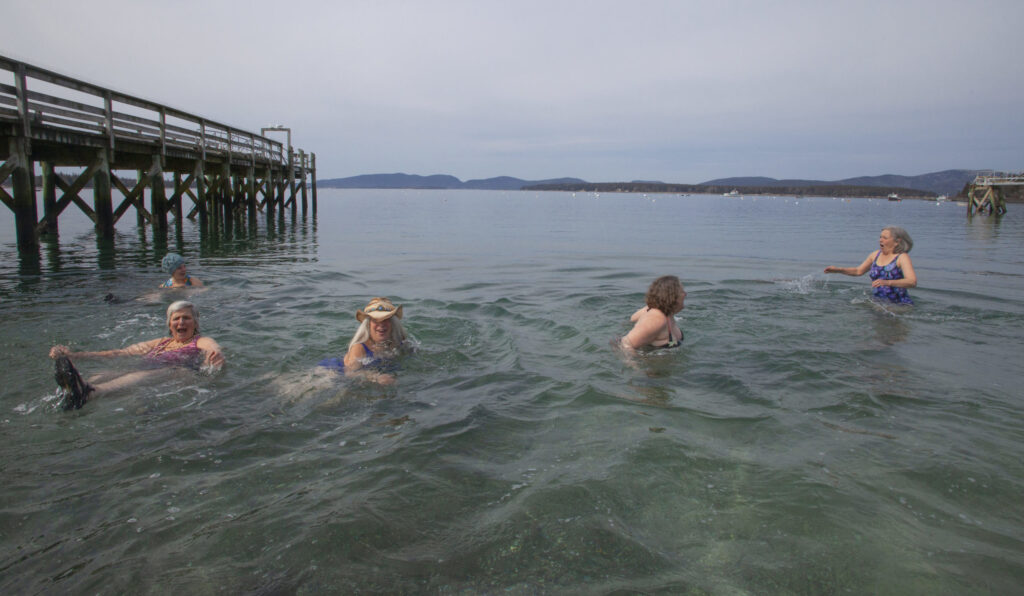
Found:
50,300 -> 224,410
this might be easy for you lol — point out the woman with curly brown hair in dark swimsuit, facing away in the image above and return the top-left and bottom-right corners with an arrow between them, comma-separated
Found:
621,275 -> 686,350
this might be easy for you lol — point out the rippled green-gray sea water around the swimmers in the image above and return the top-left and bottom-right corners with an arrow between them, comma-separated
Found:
0,189 -> 1024,594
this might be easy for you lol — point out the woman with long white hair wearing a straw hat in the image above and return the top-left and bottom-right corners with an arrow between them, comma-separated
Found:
321,297 -> 408,385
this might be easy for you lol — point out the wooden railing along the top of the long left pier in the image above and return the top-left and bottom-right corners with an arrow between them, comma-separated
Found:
0,55 -> 289,166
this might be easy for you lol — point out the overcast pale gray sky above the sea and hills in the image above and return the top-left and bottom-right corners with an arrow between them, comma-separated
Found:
0,0 -> 1024,183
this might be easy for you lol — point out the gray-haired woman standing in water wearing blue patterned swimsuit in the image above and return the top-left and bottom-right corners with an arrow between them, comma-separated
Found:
825,225 -> 918,304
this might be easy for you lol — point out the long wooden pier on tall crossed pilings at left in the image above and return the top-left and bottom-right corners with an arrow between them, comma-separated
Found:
0,55 -> 316,251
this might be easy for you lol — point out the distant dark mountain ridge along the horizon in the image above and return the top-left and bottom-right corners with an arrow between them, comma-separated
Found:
316,170 -> 987,197
